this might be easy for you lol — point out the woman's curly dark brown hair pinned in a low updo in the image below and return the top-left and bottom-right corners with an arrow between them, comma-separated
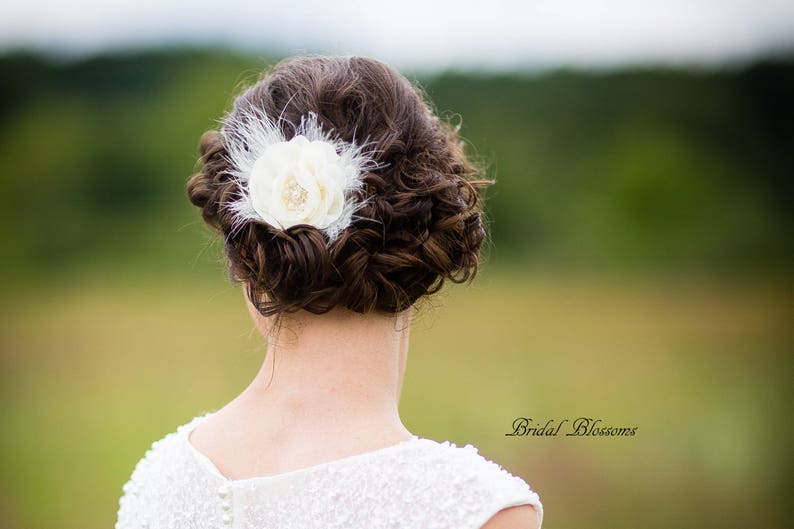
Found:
187,56 -> 492,316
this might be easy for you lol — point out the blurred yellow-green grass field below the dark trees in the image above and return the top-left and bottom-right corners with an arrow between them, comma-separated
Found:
0,271 -> 793,529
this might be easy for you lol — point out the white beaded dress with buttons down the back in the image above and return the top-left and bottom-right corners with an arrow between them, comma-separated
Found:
115,412 -> 543,529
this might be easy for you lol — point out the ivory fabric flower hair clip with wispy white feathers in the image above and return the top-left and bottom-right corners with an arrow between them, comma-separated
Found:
221,109 -> 383,244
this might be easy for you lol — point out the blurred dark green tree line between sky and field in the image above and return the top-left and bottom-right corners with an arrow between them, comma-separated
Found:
0,50 -> 794,278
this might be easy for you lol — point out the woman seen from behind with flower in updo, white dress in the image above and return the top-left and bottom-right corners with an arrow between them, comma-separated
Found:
116,56 -> 543,529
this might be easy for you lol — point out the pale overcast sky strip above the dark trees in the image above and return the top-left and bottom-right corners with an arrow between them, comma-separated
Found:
0,0 -> 794,70
